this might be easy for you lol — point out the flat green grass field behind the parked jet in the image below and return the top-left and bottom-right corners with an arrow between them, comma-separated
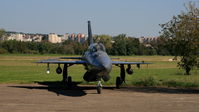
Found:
0,54 -> 199,88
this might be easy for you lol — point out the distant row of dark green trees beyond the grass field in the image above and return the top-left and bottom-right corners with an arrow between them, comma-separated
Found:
0,34 -> 173,56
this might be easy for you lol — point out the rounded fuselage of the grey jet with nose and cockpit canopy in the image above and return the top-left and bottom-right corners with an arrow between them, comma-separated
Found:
83,43 -> 112,81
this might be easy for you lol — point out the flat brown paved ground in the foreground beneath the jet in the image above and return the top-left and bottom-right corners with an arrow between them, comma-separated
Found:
0,83 -> 199,112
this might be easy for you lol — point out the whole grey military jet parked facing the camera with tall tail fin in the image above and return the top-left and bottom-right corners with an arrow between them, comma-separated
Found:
36,21 -> 150,94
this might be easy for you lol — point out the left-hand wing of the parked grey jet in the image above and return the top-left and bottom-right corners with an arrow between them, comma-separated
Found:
36,59 -> 87,64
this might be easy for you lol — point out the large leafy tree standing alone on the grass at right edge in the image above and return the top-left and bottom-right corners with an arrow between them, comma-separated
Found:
161,2 -> 199,75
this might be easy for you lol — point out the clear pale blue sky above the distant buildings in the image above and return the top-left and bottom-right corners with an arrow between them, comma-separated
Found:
0,0 -> 199,37
